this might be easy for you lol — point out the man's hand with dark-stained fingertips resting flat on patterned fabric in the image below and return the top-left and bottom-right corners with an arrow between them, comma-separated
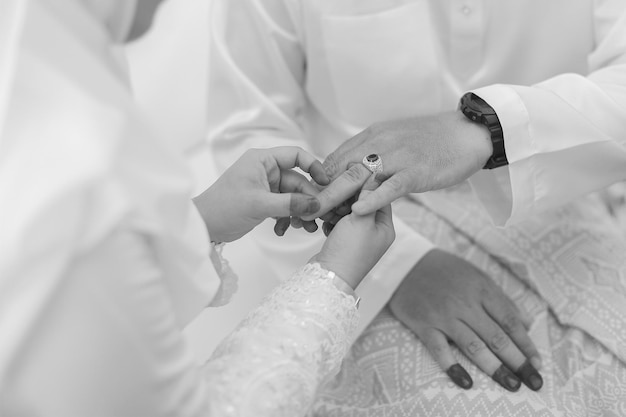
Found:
390,249 -> 543,391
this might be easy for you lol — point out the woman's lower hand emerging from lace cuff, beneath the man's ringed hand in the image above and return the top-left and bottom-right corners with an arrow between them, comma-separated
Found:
311,175 -> 395,288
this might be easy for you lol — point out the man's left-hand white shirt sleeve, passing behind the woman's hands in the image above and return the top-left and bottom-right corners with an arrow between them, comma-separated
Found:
208,0 -> 433,328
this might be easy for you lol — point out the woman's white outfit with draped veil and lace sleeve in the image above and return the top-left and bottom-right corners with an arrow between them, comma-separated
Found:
0,0 -> 358,417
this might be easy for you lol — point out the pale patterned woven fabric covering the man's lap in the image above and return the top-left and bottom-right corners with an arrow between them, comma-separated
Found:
311,185 -> 626,417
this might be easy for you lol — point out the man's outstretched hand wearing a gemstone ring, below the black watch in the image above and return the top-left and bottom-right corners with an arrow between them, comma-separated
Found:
310,111 -> 493,216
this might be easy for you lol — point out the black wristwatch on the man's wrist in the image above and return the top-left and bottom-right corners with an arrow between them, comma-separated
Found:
459,93 -> 509,169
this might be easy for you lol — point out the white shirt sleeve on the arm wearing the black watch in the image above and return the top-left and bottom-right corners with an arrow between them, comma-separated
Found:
470,1 -> 626,225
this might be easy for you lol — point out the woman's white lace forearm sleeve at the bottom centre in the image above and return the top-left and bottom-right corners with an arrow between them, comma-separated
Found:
204,264 -> 358,417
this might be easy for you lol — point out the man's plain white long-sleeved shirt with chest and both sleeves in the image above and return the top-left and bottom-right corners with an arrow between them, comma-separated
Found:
208,0 -> 626,326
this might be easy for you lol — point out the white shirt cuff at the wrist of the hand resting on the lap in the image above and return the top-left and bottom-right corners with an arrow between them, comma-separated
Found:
355,214 -> 434,337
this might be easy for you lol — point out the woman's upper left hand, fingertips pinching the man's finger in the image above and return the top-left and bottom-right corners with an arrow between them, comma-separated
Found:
194,146 -> 329,242
